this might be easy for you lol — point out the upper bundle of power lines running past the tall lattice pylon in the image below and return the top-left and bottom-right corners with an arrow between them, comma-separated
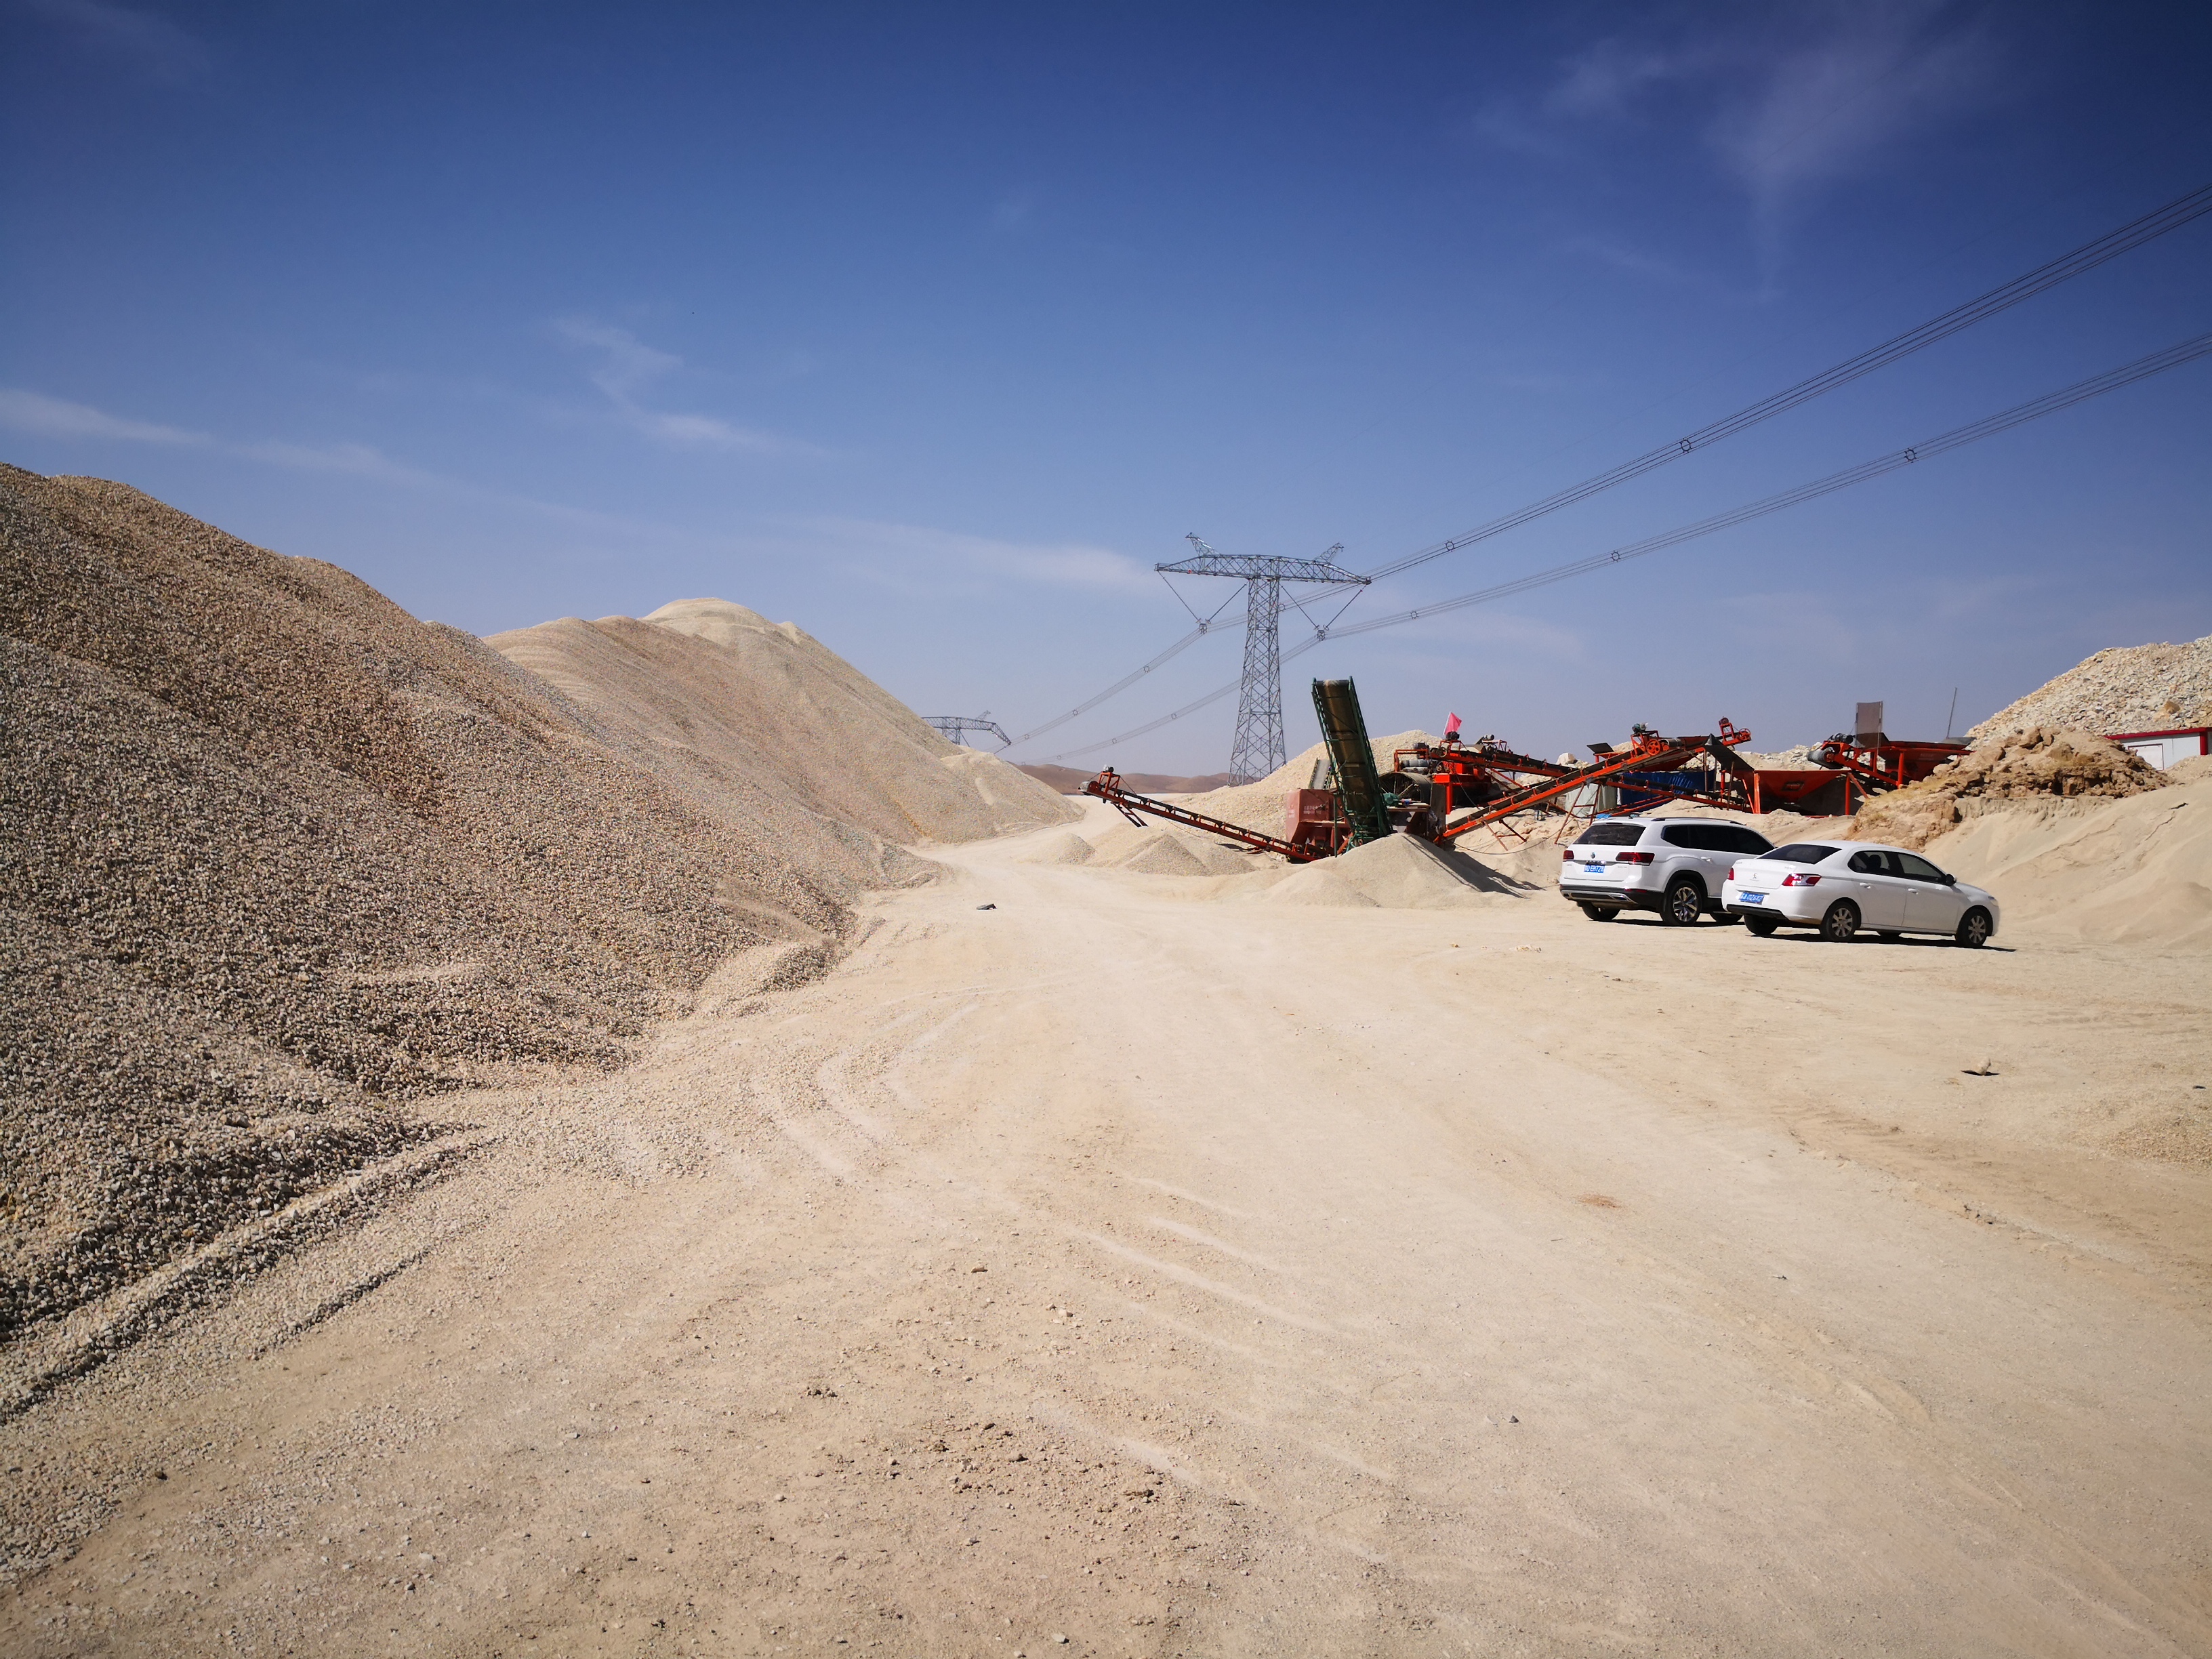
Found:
1015,184 -> 2212,754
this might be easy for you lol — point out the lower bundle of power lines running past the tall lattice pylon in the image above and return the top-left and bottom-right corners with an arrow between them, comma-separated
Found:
1031,334 -> 2212,761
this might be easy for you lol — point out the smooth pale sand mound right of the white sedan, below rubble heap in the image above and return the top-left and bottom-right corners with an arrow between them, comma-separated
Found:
1920,779 -> 2212,945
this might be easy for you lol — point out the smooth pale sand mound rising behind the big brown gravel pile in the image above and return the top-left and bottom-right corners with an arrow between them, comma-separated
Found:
487,600 -> 1080,843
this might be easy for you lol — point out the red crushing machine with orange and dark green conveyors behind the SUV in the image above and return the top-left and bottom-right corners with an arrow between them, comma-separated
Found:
1084,679 -> 1752,865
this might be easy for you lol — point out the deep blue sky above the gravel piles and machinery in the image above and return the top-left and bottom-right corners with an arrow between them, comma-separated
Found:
13,0 -> 2212,770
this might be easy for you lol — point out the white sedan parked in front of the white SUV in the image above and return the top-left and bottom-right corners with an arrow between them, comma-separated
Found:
1721,840 -> 1997,949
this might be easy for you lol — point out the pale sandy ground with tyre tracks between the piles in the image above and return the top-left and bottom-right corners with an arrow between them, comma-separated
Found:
0,810 -> 2212,1657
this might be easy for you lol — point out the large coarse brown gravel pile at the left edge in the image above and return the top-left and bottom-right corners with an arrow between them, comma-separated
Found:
0,467 -> 1044,1336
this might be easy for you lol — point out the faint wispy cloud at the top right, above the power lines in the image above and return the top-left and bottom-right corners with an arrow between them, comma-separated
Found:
1477,0 -> 2000,279
